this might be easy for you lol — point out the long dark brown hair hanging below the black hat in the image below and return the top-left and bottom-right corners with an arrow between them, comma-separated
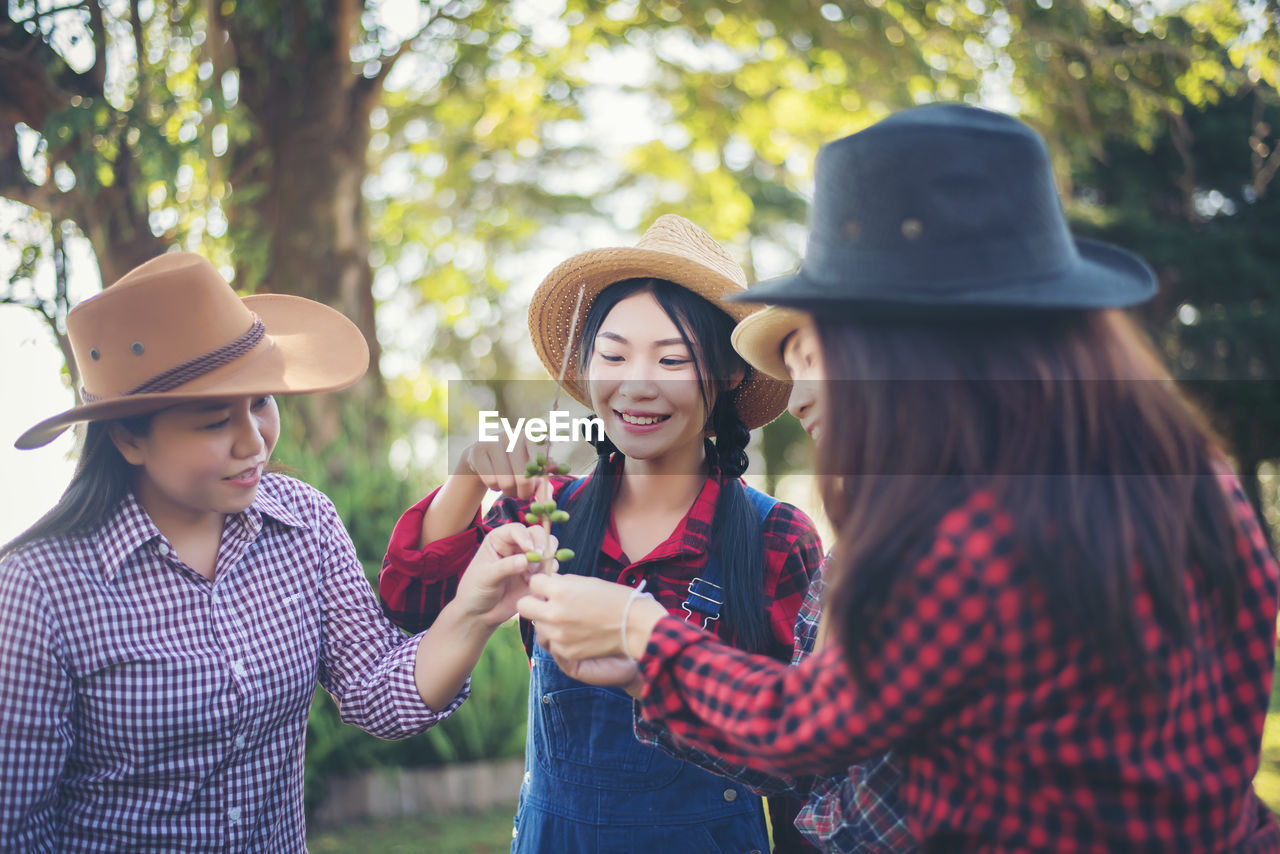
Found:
815,311 -> 1242,679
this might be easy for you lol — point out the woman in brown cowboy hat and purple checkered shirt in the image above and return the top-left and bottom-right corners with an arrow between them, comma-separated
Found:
0,252 -> 545,851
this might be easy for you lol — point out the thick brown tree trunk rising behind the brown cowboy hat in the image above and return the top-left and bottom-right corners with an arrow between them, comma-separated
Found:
221,0 -> 385,460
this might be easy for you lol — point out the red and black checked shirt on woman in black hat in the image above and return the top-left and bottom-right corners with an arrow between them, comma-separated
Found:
640,475 -> 1280,854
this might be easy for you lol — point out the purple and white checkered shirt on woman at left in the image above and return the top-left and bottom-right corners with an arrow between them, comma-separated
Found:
0,474 -> 468,851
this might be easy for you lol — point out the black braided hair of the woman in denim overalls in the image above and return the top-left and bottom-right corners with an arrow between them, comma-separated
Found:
562,279 -> 769,652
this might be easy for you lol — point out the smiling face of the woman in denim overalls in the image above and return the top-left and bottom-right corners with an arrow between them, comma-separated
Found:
586,291 -> 709,462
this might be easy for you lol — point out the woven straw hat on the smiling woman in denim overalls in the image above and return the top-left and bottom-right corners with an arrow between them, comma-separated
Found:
529,214 -> 790,430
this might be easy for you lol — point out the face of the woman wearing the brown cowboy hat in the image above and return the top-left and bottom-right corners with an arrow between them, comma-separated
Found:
111,397 -> 280,529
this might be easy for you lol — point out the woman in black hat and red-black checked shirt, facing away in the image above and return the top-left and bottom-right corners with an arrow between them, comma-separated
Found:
520,105 -> 1280,851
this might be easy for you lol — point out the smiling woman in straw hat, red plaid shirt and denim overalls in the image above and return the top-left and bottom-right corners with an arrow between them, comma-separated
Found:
379,215 -> 820,854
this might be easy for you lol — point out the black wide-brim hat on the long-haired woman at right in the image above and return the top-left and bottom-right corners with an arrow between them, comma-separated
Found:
731,104 -> 1156,314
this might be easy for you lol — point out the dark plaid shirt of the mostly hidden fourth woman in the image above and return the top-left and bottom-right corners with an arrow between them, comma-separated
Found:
634,553 -> 918,854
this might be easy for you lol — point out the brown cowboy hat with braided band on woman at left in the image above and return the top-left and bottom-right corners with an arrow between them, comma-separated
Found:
14,252 -> 369,449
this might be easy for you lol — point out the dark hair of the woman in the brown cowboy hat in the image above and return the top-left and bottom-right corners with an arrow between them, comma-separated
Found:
0,414 -> 154,560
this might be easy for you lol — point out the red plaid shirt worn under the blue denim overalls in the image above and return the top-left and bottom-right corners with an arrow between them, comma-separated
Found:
378,470 -> 822,850
